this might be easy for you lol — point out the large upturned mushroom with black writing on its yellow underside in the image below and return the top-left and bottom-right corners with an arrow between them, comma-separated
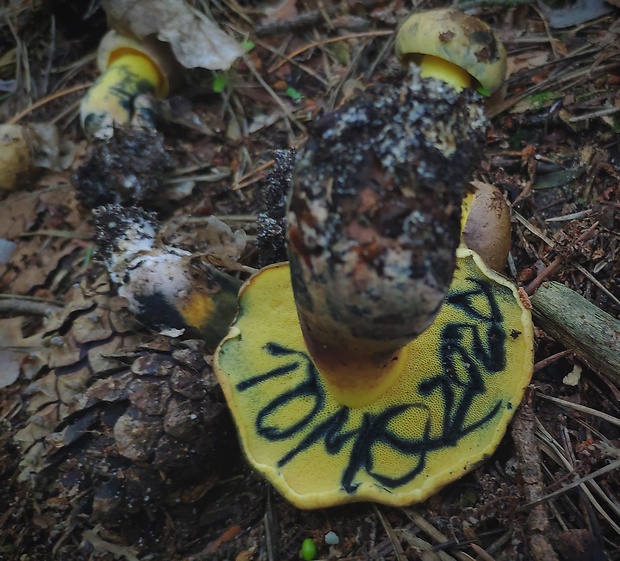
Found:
214,10 -> 533,508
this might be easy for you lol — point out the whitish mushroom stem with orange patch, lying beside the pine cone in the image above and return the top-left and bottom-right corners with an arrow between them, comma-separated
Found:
93,204 -> 241,350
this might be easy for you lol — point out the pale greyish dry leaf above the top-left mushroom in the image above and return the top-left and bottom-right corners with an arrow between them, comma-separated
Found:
101,0 -> 243,70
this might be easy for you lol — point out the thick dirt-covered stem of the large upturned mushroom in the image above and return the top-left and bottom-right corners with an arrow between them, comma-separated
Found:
287,73 -> 487,406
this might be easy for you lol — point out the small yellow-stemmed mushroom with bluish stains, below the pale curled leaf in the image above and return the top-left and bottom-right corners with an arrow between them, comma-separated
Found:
80,30 -> 181,136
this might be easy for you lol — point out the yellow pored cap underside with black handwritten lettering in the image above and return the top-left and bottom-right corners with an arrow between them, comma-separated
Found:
214,248 -> 533,508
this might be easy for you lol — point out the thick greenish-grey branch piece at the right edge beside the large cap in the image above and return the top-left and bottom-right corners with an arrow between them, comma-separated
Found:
531,282 -> 620,383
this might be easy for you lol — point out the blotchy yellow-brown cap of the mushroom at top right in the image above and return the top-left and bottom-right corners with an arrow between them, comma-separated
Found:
395,8 -> 506,95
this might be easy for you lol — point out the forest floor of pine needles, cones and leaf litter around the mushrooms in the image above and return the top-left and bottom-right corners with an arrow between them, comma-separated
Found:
0,0 -> 620,561
